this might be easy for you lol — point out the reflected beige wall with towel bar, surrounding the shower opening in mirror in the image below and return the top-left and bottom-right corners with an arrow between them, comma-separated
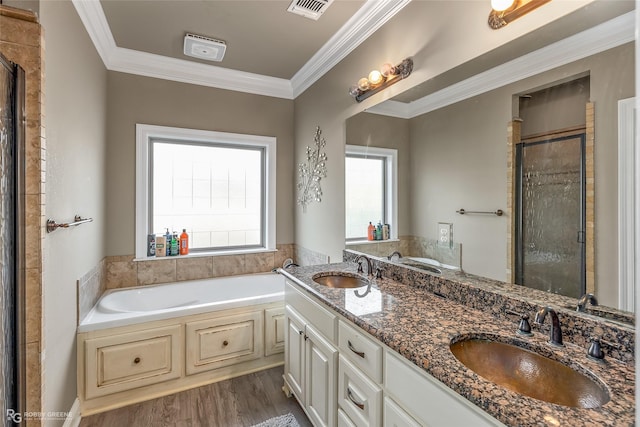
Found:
411,43 -> 635,306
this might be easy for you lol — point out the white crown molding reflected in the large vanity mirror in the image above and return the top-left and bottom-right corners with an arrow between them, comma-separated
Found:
367,11 -> 635,119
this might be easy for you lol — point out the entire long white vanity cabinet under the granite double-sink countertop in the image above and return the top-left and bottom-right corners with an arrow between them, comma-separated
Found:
284,282 -> 503,427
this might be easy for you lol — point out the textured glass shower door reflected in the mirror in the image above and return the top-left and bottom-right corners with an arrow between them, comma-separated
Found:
516,134 -> 586,298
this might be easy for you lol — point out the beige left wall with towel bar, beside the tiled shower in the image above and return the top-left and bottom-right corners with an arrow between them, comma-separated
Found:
40,1 -> 107,425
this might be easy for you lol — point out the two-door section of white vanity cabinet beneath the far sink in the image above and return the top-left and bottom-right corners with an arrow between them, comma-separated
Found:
284,284 -> 338,427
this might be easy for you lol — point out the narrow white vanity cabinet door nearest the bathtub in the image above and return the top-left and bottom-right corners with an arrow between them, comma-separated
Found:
284,305 -> 305,406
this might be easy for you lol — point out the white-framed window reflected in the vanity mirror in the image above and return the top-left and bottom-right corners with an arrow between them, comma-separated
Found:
345,145 -> 398,241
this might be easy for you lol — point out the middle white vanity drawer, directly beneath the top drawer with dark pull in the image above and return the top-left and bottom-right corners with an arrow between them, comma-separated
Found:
338,355 -> 382,427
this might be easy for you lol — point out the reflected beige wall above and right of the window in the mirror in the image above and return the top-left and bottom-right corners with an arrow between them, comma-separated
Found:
346,113 -> 411,236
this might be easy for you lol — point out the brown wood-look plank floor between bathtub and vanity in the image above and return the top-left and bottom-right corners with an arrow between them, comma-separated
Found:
80,367 -> 311,427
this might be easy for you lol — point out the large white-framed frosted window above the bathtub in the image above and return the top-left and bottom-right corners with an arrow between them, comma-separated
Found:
136,124 -> 276,258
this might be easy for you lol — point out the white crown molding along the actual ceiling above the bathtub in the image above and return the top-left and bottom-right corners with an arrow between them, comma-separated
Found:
72,0 -> 411,99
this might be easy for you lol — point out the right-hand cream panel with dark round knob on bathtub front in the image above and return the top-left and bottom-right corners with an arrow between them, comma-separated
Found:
186,311 -> 263,375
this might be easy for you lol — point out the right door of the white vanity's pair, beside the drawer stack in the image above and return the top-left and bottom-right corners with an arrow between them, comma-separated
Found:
305,325 -> 338,427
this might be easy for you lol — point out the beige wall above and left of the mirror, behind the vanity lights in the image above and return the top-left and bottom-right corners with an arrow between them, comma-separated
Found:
294,1 -> 599,261
